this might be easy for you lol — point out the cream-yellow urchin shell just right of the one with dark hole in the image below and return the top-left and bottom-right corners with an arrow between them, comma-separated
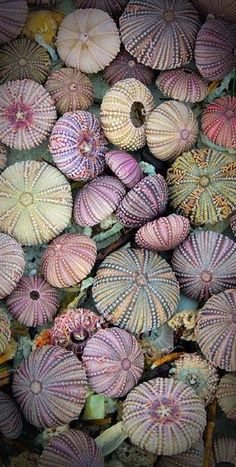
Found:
146,101 -> 198,160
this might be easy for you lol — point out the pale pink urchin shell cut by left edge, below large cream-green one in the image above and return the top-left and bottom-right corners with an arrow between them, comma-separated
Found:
0,234 -> 26,299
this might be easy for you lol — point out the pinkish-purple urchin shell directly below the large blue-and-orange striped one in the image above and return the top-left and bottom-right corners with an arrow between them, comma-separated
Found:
82,328 -> 144,397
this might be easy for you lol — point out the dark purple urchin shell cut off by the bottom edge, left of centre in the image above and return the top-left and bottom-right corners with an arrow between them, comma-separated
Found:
38,430 -> 104,467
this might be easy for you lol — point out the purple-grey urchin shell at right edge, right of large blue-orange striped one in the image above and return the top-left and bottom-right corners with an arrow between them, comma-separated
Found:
171,231 -> 236,301
